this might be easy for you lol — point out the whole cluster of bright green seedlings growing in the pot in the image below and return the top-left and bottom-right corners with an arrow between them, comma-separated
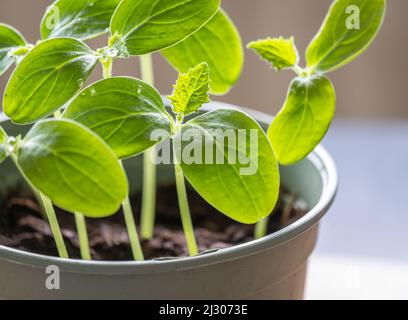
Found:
0,0 -> 386,260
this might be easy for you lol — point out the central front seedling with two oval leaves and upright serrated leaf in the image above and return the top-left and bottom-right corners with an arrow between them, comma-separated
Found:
63,63 -> 279,255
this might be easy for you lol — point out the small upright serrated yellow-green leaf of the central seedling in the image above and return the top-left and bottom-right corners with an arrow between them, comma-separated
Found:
168,63 -> 210,115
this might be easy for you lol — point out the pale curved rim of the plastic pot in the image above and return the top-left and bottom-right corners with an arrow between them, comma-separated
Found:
0,102 -> 338,274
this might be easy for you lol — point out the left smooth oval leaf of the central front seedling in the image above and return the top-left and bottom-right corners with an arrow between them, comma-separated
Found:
63,77 -> 171,159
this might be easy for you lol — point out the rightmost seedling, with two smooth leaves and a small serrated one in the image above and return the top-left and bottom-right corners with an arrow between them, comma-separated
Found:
248,0 -> 386,237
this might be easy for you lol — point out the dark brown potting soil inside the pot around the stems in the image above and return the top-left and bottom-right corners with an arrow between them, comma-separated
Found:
0,186 -> 307,261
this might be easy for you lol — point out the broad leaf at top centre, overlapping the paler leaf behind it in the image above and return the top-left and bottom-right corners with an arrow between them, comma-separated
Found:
110,0 -> 221,55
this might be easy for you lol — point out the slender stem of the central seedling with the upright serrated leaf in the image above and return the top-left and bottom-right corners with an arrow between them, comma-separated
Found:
174,164 -> 198,256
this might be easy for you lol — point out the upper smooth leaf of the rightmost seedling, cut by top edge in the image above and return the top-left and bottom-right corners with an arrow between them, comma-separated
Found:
306,0 -> 386,72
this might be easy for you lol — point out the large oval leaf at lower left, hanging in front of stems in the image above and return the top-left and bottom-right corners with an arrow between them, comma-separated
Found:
18,120 -> 128,218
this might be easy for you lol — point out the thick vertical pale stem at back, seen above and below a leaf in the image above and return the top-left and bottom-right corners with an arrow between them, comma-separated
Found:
140,54 -> 157,239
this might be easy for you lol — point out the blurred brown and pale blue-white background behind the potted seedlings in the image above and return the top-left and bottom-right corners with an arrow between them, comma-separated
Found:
0,0 -> 408,299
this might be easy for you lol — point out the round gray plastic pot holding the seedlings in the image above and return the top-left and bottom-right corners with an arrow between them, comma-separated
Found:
0,103 -> 337,299
